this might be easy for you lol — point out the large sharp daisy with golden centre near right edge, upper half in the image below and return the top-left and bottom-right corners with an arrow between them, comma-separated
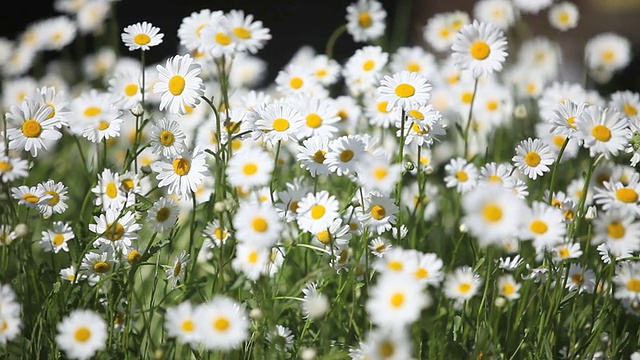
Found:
576,105 -> 632,158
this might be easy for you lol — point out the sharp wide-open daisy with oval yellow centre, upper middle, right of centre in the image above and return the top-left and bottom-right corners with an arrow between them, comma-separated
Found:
378,70 -> 431,110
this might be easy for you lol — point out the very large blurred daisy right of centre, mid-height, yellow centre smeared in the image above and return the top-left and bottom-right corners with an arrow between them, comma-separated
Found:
462,185 -> 526,246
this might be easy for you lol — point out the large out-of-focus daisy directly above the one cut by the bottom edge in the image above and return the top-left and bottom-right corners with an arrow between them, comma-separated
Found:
365,273 -> 432,329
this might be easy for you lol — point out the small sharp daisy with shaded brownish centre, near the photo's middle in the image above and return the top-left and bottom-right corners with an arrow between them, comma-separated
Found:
356,191 -> 399,235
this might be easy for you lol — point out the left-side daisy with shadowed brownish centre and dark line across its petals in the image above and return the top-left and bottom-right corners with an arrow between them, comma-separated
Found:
89,210 -> 142,255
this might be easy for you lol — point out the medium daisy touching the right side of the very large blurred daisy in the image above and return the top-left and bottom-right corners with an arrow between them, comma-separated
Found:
520,201 -> 567,250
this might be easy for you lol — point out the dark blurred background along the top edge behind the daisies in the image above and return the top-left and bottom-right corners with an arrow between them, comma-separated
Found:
0,0 -> 640,91
